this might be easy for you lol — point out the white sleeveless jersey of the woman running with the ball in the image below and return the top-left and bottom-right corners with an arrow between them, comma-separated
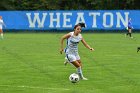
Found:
65,32 -> 82,54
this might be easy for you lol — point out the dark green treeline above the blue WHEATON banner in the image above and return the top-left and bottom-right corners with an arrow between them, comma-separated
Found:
0,0 -> 140,10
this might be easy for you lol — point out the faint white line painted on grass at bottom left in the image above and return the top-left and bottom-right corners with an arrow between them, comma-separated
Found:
0,85 -> 70,90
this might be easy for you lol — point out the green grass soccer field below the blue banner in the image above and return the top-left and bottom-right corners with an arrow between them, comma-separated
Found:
0,33 -> 140,93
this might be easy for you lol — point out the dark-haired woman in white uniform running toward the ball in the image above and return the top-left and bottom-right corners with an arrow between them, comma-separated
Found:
60,23 -> 94,80
